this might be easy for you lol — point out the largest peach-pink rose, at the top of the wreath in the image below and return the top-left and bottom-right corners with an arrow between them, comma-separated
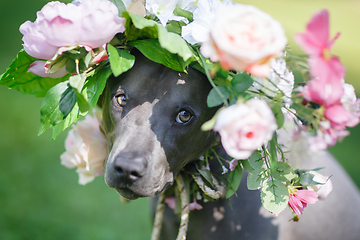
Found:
201,4 -> 287,77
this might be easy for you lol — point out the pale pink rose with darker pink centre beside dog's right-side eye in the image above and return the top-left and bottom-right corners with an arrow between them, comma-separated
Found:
214,98 -> 277,159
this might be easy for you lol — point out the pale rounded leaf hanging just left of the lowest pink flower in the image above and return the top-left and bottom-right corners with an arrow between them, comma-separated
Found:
260,179 -> 289,215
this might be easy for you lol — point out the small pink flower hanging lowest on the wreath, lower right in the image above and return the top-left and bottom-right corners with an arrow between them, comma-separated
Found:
288,186 -> 318,215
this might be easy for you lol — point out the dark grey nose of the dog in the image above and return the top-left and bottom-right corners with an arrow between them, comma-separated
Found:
114,154 -> 147,181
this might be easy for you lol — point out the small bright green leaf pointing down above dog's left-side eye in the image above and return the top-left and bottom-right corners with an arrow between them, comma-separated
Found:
107,44 -> 135,77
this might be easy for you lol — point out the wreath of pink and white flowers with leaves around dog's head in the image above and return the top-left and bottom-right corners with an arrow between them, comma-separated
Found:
0,0 -> 360,239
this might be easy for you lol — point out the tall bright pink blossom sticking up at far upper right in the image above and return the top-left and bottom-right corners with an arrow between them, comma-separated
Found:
295,10 -> 345,105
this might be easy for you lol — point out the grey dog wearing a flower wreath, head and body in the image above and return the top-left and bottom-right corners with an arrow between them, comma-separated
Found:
101,52 -> 360,240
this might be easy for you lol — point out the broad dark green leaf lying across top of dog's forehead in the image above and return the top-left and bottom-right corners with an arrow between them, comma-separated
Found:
128,38 -> 186,72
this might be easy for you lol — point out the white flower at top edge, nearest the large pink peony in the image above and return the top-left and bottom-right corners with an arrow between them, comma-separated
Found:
145,0 -> 195,26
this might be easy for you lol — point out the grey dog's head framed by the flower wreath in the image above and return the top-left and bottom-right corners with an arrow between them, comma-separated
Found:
102,53 -> 216,199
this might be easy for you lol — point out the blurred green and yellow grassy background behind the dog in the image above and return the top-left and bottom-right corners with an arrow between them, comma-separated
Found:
0,0 -> 360,240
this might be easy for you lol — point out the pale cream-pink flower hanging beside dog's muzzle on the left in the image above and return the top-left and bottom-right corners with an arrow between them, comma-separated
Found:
60,109 -> 108,185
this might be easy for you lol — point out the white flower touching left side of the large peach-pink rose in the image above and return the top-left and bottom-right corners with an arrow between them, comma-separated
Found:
181,0 -> 237,44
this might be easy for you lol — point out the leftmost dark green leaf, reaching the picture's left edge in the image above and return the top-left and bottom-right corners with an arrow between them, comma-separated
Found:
0,49 -> 69,97
